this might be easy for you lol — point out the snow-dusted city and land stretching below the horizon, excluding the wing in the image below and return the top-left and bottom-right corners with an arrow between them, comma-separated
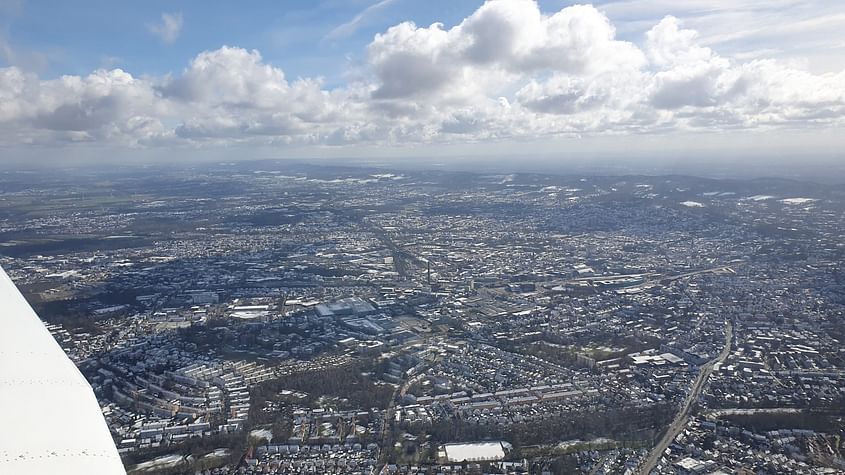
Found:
0,161 -> 845,474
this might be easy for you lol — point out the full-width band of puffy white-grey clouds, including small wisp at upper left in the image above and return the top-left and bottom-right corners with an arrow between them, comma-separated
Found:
0,0 -> 845,152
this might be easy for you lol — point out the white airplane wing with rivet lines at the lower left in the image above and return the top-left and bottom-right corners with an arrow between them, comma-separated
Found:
0,268 -> 126,475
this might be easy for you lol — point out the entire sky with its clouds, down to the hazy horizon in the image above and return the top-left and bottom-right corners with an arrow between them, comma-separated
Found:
0,0 -> 845,164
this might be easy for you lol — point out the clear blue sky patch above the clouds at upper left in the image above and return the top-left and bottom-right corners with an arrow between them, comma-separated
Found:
3,0 -> 502,84
